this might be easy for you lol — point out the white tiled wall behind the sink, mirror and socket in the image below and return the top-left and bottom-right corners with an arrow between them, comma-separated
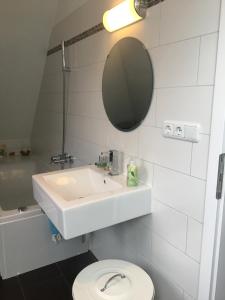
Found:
32,0 -> 220,300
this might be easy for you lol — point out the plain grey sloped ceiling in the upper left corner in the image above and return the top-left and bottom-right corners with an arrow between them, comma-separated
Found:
0,0 -> 58,140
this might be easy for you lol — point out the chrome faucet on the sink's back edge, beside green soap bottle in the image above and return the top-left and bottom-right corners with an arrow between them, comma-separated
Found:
109,150 -> 123,176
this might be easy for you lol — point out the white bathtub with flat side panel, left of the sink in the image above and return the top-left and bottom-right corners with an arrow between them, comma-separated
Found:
0,156 -> 88,279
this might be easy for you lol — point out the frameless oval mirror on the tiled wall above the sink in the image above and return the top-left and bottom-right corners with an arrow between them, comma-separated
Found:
102,37 -> 154,131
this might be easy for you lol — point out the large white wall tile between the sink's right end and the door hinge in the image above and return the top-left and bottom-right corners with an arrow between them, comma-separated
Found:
153,166 -> 205,222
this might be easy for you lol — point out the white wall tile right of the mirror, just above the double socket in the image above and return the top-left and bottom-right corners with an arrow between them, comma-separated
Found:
156,86 -> 213,133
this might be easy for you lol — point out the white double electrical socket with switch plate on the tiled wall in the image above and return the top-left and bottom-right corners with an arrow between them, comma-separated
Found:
163,121 -> 200,143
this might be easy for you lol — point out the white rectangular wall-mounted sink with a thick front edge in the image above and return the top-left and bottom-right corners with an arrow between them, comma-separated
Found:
33,166 -> 151,239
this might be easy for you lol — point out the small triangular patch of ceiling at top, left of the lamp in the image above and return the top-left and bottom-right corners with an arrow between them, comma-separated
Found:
55,0 -> 88,24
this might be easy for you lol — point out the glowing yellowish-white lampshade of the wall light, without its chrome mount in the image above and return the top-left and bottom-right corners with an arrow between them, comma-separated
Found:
103,0 -> 142,32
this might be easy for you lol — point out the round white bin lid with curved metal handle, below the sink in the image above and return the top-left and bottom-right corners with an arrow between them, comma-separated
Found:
73,260 -> 154,300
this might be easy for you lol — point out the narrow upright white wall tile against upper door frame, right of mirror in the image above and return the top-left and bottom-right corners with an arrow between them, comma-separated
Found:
198,33 -> 218,85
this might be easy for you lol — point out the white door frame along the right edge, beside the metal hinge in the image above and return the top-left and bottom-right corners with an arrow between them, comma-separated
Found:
198,0 -> 225,300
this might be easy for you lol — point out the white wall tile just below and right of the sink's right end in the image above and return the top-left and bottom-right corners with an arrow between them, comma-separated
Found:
151,201 -> 188,251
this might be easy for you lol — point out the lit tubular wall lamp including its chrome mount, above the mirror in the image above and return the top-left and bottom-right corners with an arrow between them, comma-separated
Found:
103,0 -> 164,32
